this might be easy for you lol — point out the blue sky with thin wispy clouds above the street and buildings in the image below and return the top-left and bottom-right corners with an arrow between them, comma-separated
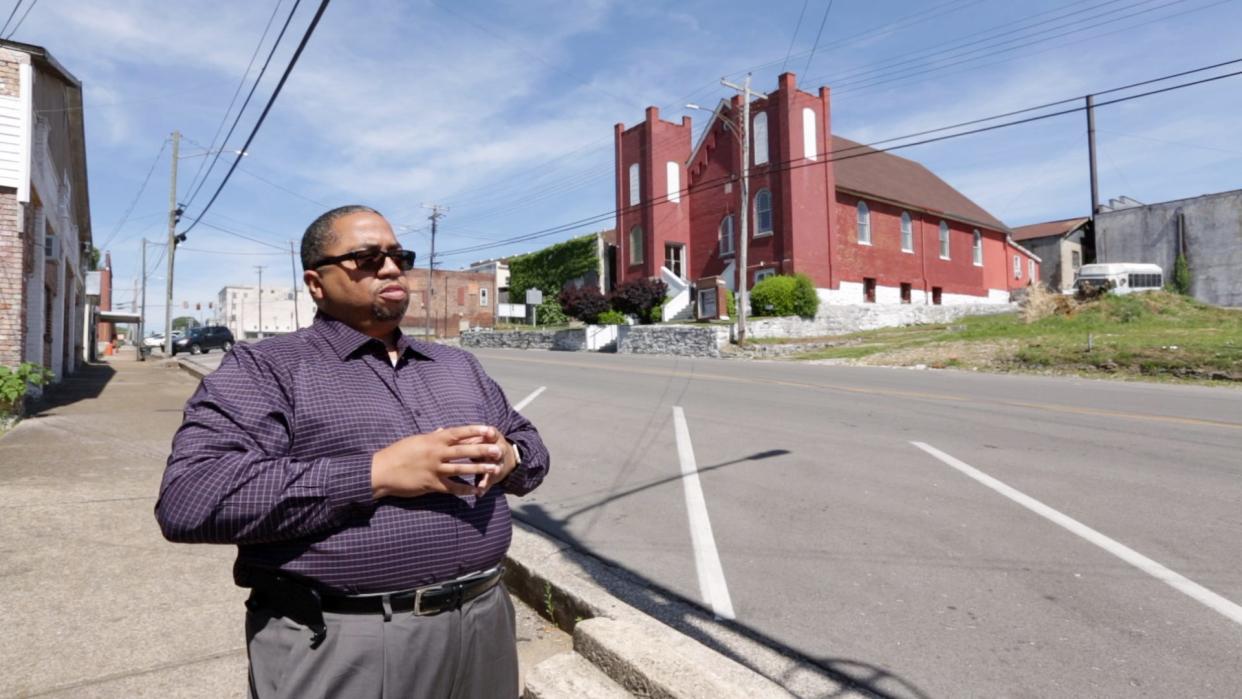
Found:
12,0 -> 1242,329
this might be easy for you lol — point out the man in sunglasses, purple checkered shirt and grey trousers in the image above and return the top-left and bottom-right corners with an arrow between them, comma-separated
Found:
155,206 -> 549,699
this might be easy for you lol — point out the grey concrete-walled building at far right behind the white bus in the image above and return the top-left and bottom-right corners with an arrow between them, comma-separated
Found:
1095,190 -> 1242,307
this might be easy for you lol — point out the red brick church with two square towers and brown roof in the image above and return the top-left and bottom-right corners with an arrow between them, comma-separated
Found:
615,73 -> 1040,304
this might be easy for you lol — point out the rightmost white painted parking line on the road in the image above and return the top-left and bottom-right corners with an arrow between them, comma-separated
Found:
910,442 -> 1242,623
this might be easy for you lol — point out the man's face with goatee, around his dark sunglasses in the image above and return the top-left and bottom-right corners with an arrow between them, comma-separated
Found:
304,212 -> 410,336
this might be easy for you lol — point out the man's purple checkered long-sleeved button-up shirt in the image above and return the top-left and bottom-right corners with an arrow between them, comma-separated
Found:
155,313 -> 549,593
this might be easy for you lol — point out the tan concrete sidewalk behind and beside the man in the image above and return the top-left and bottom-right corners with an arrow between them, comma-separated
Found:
0,355 -> 571,699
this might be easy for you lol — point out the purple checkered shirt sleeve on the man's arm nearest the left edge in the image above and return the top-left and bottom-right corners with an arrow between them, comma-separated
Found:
155,345 -> 374,544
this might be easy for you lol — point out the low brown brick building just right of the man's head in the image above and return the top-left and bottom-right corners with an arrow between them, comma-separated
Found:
401,268 -> 497,338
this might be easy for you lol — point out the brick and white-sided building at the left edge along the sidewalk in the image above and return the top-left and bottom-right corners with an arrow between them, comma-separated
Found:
0,41 -> 92,381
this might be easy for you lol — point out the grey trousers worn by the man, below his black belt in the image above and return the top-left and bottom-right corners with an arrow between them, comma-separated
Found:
246,585 -> 518,699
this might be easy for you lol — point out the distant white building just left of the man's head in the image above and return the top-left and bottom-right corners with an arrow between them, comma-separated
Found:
215,284 -> 315,340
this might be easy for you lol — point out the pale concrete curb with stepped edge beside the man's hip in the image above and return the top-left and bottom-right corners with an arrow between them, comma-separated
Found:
505,523 -> 794,699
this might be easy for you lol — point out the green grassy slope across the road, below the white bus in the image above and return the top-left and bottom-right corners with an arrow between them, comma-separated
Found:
799,292 -> 1242,381
